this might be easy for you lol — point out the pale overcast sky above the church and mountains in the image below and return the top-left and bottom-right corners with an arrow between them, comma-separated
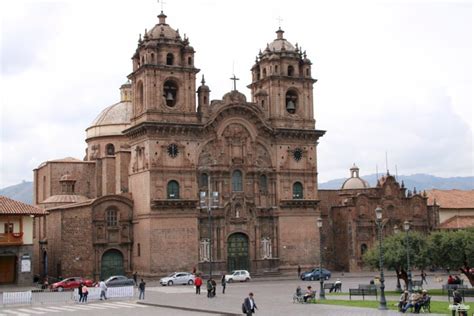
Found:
0,0 -> 474,188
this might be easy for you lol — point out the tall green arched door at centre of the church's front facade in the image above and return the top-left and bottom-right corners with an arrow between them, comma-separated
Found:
227,233 -> 249,271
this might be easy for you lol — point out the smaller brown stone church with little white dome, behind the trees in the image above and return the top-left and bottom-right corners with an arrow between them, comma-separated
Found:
319,165 -> 439,272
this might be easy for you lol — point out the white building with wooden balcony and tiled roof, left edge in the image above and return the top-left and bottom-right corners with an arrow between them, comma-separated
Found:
0,195 -> 46,286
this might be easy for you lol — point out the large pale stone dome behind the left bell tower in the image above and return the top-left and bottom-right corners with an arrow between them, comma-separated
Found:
86,84 -> 132,139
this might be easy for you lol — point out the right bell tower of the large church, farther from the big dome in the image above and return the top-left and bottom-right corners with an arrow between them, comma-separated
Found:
248,28 -> 316,129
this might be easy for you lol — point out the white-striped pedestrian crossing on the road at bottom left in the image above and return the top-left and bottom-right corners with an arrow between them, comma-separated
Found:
0,302 -> 148,316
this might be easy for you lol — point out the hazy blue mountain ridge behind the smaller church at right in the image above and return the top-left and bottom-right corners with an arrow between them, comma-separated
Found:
319,173 -> 474,191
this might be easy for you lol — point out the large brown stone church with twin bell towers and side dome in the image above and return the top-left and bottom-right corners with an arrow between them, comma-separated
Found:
34,13 -> 324,278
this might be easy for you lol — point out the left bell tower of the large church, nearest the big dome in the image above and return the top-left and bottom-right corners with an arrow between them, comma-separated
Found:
128,11 -> 199,124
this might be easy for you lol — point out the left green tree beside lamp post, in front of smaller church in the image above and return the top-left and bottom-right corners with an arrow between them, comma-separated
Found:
363,232 -> 430,288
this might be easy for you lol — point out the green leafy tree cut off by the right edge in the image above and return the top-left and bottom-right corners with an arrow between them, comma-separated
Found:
428,228 -> 474,286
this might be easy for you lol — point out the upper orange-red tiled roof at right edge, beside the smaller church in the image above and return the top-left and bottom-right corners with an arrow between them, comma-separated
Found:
426,190 -> 474,209
